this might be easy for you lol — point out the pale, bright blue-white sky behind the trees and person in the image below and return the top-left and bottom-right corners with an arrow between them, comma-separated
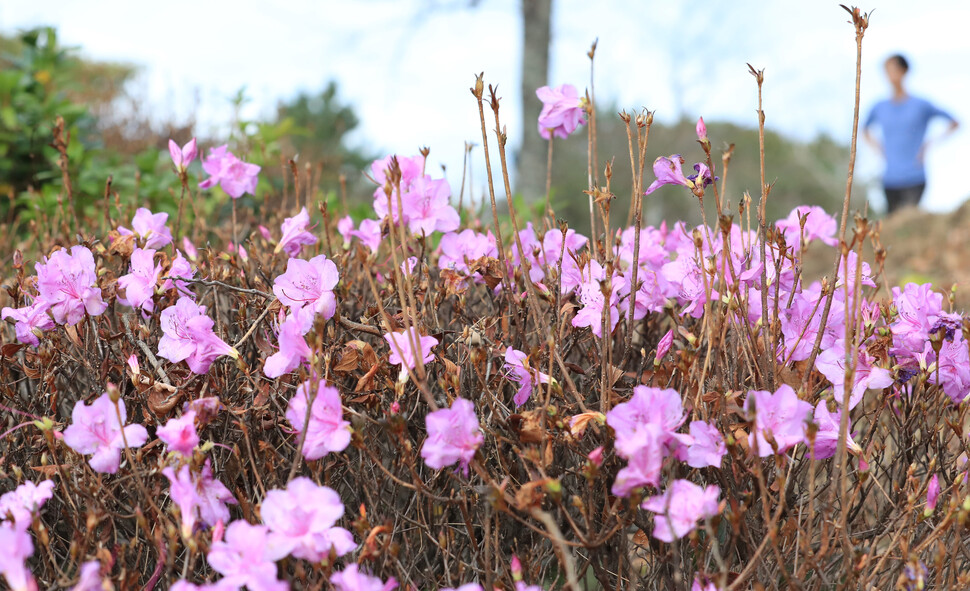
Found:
0,0 -> 970,212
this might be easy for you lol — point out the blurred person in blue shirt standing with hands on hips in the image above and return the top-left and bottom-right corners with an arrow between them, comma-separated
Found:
863,54 -> 959,213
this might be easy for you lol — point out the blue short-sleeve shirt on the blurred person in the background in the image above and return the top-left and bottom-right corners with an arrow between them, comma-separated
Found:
863,96 -> 954,189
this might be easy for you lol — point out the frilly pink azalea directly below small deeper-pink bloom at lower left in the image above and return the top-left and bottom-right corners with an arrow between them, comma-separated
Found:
162,458 -> 236,537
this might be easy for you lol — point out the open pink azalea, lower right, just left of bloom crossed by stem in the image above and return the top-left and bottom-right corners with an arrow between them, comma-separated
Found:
744,384 -> 813,458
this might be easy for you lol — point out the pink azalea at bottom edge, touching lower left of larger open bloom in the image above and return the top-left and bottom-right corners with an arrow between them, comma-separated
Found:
206,519 -> 289,591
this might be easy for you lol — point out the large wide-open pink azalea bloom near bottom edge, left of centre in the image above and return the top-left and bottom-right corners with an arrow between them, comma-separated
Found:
260,476 -> 357,562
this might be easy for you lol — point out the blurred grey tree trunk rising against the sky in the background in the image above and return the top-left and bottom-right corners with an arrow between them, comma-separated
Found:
515,0 -> 552,203
